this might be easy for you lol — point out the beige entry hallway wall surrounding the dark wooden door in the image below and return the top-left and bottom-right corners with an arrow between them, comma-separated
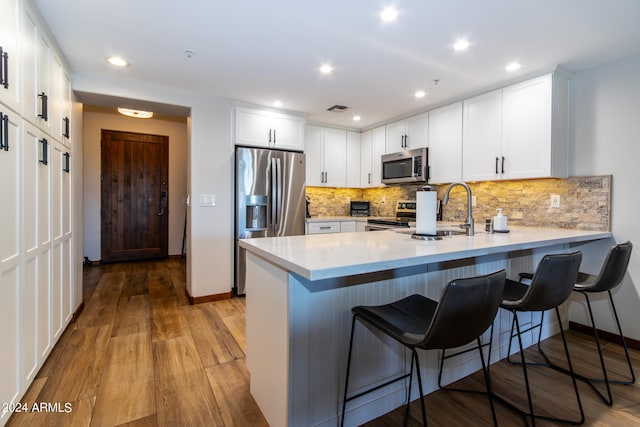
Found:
83,110 -> 188,261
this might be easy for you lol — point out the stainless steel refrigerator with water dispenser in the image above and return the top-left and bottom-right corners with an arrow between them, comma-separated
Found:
234,147 -> 306,295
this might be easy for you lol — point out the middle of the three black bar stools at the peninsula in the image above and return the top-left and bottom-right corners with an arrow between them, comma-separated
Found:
495,251 -> 584,426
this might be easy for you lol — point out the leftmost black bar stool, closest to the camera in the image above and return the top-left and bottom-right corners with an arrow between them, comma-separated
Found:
340,270 -> 506,425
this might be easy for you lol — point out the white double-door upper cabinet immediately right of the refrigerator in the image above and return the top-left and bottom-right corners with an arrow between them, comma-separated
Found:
305,125 -> 347,187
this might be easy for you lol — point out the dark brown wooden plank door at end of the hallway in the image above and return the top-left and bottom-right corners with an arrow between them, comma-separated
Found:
100,130 -> 169,262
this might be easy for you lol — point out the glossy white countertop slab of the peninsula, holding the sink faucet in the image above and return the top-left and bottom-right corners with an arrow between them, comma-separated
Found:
240,227 -> 611,280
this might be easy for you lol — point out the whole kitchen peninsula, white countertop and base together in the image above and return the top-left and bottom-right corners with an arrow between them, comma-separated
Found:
240,227 -> 611,426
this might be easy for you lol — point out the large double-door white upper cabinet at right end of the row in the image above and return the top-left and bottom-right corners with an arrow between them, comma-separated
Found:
463,73 -> 568,181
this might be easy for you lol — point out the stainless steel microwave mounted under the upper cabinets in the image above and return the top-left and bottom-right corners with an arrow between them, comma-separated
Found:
382,147 -> 429,184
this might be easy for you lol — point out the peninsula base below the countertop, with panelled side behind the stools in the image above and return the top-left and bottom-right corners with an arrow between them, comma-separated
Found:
247,243 -> 570,426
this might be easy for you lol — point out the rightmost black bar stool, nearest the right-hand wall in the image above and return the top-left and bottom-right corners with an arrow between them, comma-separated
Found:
520,242 -> 636,406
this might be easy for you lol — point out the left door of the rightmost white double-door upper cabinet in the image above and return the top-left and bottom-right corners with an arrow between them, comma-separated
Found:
462,90 -> 502,181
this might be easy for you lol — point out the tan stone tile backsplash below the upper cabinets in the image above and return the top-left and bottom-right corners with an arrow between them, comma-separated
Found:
307,175 -> 612,231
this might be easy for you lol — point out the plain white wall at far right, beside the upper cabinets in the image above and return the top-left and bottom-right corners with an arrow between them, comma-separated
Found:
570,56 -> 640,339
